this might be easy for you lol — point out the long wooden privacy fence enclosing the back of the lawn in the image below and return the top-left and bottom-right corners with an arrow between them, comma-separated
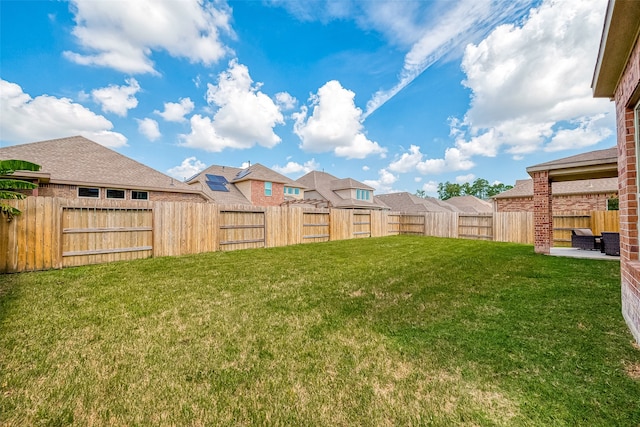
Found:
0,197 -> 619,273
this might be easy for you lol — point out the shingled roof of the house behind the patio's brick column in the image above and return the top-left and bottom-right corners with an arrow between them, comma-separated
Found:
493,178 -> 618,199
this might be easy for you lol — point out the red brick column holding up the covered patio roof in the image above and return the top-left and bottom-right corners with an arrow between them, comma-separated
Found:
533,171 -> 553,254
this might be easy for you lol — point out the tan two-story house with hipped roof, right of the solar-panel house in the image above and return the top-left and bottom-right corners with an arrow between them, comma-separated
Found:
296,171 -> 388,209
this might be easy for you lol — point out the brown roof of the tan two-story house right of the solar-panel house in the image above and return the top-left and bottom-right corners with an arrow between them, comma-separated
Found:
297,171 -> 386,209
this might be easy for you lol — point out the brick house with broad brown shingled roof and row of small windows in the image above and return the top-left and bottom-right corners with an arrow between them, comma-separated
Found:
0,136 -> 208,202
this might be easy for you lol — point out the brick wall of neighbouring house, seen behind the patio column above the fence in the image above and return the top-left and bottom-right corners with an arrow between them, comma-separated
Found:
496,193 -> 611,213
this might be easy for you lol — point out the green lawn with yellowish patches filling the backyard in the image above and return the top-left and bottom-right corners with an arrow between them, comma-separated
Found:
0,236 -> 640,426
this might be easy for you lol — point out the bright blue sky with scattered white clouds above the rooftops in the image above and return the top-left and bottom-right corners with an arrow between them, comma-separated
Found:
0,0 -> 615,195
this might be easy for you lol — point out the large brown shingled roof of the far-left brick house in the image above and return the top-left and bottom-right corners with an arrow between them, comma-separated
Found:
0,136 -> 205,197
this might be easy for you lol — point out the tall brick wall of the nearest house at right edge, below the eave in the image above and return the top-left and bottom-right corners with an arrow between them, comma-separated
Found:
615,30 -> 640,343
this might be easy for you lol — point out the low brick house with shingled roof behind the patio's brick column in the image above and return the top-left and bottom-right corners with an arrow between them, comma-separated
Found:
492,178 -> 618,212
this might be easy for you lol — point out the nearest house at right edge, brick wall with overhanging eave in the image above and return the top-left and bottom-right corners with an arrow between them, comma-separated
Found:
592,0 -> 640,343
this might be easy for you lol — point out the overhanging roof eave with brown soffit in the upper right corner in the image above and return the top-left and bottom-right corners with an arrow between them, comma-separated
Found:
591,0 -> 640,98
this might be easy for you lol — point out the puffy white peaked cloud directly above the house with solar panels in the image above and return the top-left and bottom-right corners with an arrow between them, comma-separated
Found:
179,60 -> 284,152
